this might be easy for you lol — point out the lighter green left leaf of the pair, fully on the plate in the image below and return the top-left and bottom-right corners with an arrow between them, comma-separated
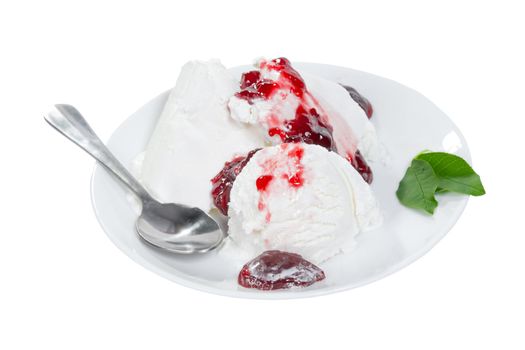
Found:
396,159 -> 440,214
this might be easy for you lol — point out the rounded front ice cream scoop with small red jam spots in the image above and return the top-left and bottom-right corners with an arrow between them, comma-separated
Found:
227,143 -> 382,263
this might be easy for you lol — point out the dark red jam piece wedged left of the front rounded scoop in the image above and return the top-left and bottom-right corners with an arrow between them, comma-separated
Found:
211,148 -> 260,215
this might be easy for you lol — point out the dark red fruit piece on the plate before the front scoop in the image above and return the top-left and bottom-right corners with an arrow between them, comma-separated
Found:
237,250 -> 325,290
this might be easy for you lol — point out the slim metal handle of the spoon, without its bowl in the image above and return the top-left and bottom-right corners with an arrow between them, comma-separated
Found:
44,104 -> 154,203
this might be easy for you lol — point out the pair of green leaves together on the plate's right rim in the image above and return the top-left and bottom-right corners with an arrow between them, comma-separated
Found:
396,152 -> 485,214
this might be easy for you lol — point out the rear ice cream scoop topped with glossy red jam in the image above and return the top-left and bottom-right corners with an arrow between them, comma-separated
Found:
228,58 -> 380,183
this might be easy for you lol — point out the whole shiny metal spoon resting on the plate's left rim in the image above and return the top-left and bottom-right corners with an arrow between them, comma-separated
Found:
44,104 -> 226,254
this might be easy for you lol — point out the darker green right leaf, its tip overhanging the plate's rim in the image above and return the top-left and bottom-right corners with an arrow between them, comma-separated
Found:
415,152 -> 485,196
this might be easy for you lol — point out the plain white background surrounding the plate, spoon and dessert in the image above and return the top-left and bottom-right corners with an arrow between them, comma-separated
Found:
0,0 -> 525,349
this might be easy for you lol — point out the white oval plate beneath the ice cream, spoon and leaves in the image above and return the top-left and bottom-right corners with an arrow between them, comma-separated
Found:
91,63 -> 470,299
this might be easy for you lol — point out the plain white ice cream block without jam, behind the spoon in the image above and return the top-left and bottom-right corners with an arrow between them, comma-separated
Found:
141,61 -> 264,210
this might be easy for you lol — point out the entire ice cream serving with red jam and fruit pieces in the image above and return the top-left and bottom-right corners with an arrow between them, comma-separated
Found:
136,58 -> 382,290
